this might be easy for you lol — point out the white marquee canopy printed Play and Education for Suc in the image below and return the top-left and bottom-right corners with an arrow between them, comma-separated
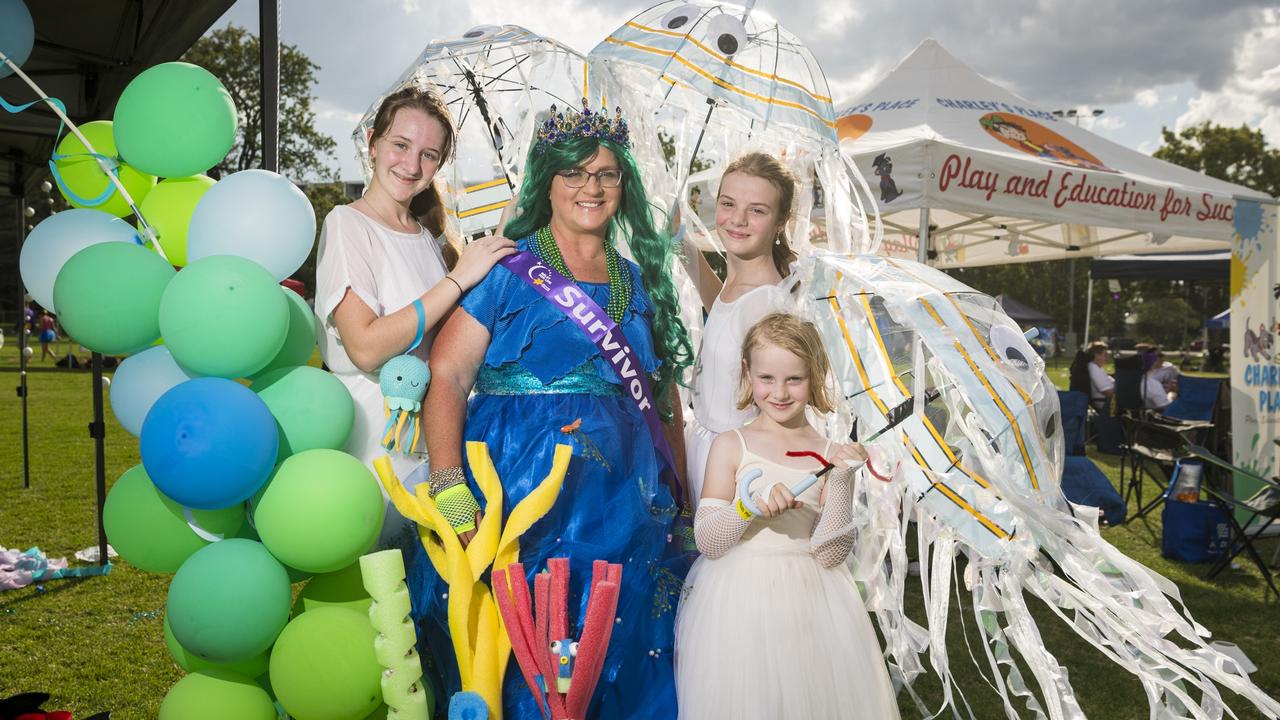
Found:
837,40 -> 1274,268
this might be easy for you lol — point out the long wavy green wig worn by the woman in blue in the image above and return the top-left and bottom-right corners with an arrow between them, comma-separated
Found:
503,137 -> 694,420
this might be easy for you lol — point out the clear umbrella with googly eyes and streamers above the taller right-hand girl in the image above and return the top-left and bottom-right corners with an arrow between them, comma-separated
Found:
589,0 -> 878,251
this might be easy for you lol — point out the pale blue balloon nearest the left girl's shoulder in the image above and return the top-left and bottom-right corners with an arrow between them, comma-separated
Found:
187,170 -> 316,281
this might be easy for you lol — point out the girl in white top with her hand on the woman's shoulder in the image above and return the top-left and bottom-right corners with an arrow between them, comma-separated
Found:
315,87 -> 515,547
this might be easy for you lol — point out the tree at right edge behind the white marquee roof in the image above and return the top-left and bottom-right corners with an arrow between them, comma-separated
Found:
1152,122 -> 1280,197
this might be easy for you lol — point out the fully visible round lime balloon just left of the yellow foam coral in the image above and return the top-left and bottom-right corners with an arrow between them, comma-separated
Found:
253,450 -> 385,571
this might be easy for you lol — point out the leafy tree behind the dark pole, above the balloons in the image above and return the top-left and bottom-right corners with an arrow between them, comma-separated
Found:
182,24 -> 338,182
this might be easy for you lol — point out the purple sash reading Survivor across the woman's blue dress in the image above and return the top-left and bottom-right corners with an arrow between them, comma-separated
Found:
498,251 -> 684,489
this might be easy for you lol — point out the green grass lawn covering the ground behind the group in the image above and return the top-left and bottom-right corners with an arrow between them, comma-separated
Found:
0,343 -> 1280,720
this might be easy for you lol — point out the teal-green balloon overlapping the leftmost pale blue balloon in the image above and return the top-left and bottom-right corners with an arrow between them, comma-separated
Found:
54,242 -> 175,355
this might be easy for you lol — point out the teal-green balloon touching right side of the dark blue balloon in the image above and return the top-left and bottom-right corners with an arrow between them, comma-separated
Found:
250,365 -> 356,460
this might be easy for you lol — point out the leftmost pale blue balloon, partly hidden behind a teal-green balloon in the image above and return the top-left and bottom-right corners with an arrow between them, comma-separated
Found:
17,206 -> 138,313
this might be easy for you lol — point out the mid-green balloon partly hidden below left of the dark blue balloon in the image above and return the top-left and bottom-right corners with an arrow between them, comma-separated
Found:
102,465 -> 246,573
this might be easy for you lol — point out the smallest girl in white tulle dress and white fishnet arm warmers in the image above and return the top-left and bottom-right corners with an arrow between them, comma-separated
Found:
676,314 -> 899,720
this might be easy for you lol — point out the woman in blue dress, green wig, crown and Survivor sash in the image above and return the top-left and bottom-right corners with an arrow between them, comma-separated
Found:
410,102 -> 692,720
